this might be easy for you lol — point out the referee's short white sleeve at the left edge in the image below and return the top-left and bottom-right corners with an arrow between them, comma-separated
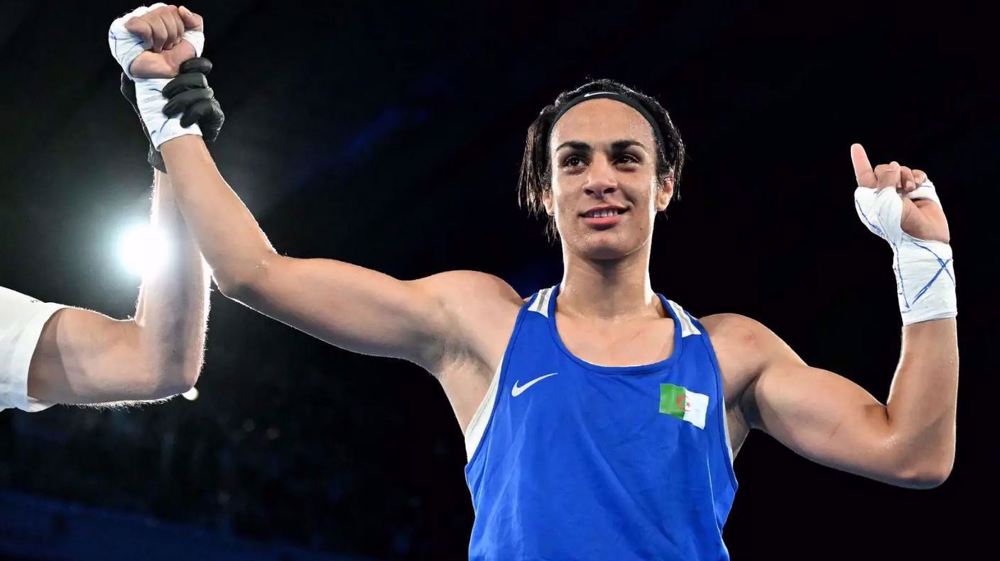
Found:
0,286 -> 65,412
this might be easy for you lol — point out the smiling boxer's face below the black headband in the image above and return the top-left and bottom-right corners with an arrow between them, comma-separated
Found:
543,99 -> 673,260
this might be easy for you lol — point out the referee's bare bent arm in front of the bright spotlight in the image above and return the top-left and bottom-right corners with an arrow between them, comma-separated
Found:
28,168 -> 208,404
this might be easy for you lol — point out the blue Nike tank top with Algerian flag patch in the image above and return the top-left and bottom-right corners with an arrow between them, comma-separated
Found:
465,285 -> 737,561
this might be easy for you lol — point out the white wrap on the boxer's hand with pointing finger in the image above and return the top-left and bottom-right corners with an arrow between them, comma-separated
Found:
854,180 -> 958,325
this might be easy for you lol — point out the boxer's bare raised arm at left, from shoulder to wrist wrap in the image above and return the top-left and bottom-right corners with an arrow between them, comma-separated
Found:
161,136 -> 500,373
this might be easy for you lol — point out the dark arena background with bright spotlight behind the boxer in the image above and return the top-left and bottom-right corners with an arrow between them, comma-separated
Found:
0,1 -> 1000,560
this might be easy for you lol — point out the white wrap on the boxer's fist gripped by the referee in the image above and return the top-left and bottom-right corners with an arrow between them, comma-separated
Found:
108,3 -> 205,150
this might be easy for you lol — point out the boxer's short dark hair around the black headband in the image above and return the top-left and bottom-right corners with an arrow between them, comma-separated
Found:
517,79 -> 684,241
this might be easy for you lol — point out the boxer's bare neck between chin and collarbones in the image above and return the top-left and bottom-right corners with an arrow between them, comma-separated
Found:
557,240 -> 664,321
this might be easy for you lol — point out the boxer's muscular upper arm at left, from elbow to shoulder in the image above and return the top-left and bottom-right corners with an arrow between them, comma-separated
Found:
231,255 -> 508,369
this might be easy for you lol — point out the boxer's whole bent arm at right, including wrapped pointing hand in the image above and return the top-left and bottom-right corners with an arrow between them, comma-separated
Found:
736,144 -> 958,487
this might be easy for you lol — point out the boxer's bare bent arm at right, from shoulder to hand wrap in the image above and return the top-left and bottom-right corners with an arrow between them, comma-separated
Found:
741,318 -> 958,488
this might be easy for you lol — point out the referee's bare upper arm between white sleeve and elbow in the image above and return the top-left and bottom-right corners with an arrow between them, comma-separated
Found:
28,308 -> 162,404
